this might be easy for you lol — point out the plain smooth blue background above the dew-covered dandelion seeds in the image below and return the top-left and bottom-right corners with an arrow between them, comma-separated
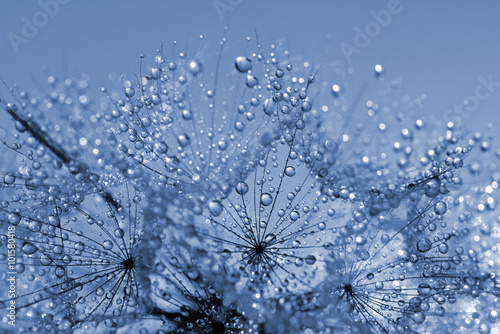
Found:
0,0 -> 500,130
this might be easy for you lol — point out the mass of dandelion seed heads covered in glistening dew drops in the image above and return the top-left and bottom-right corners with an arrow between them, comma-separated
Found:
0,30 -> 500,334
